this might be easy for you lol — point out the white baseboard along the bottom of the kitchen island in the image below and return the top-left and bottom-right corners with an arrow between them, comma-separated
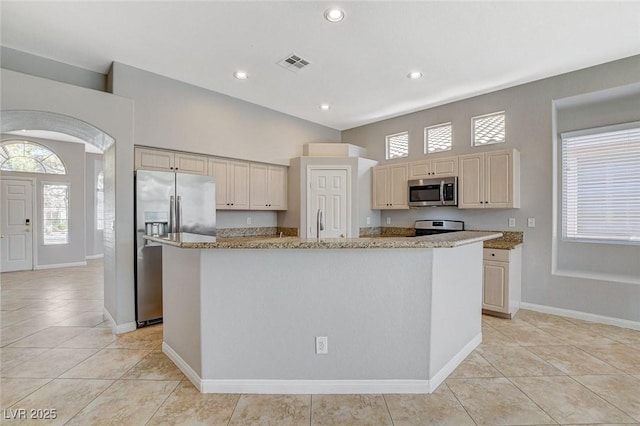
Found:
162,334 -> 482,394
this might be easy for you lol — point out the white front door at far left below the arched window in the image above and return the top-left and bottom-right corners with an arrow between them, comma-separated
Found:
0,179 -> 33,272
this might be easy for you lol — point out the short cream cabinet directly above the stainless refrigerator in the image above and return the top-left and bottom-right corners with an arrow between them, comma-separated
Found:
134,147 -> 208,175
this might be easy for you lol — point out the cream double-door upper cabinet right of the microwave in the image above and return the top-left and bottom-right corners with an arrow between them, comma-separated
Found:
458,149 -> 520,209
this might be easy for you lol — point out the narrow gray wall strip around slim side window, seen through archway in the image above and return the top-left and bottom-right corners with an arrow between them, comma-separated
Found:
85,153 -> 103,258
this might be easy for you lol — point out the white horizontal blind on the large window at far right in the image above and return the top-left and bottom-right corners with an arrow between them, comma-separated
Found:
562,122 -> 640,244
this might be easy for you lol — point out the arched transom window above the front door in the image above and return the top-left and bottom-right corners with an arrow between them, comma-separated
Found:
0,140 -> 67,175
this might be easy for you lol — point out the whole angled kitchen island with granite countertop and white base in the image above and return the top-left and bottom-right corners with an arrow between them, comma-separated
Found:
145,231 -> 501,394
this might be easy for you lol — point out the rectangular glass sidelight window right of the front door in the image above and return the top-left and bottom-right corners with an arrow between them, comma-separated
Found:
42,184 -> 69,245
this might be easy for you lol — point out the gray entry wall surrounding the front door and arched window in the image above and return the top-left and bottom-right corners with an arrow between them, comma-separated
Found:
2,134 -> 85,269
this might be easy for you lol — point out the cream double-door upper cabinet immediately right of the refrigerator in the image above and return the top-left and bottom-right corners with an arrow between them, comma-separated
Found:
209,158 -> 250,210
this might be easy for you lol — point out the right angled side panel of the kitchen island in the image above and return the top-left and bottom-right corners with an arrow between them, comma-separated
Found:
429,242 -> 482,386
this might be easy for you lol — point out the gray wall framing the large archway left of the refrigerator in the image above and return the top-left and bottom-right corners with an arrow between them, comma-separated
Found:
0,69 -> 135,331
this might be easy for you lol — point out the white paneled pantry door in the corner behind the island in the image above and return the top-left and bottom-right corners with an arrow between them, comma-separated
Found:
307,169 -> 350,238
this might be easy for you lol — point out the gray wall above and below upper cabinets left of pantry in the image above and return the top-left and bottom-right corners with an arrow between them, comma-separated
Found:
110,62 -> 341,228
